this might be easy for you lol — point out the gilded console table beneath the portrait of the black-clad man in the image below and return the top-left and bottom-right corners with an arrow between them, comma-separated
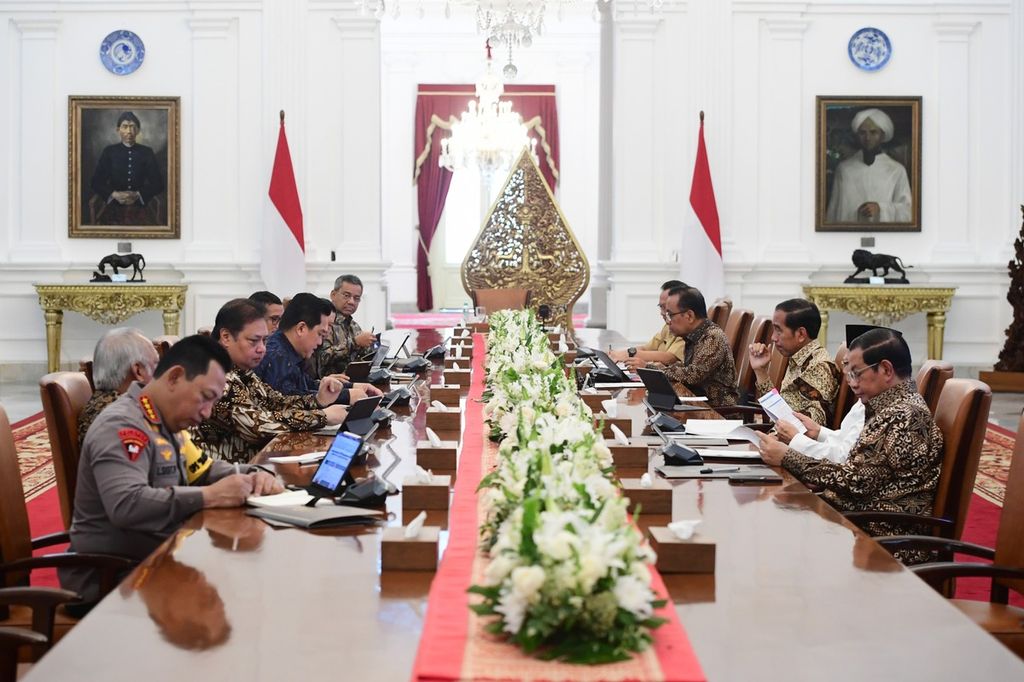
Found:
33,283 -> 188,372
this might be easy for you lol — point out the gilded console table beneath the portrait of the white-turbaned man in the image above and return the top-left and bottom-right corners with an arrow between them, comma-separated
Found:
804,285 -> 956,359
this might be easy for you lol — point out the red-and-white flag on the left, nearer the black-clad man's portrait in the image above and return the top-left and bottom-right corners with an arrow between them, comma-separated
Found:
260,113 -> 306,298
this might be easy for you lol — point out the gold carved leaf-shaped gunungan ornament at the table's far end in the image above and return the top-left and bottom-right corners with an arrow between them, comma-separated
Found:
462,151 -> 590,331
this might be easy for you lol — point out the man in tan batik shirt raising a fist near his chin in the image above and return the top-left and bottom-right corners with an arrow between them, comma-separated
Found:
749,298 -> 840,426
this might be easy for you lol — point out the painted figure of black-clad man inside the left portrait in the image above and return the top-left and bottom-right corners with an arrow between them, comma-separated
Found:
89,112 -> 165,225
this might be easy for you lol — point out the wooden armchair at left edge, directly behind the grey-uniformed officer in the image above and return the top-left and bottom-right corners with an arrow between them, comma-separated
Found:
0,406 -> 134,660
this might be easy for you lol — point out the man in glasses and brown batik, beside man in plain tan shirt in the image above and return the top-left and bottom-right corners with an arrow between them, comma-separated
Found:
647,287 -> 738,407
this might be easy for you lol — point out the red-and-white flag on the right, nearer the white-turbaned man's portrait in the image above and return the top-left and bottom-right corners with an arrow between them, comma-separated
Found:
680,112 -> 725,306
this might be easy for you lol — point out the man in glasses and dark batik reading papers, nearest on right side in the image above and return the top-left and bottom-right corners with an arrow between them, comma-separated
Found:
759,329 -> 942,563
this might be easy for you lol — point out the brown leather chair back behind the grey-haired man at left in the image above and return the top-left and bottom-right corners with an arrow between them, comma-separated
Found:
39,372 -> 92,528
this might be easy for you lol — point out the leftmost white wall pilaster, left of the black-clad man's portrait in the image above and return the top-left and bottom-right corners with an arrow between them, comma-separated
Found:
9,18 -> 60,262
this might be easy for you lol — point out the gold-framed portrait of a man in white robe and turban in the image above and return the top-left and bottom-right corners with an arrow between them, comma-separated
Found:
814,96 -> 921,232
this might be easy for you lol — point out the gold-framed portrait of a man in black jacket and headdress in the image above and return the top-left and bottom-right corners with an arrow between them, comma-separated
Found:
68,95 -> 181,239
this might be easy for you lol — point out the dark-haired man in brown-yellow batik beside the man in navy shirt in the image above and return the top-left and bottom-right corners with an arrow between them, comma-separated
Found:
196,298 -> 346,463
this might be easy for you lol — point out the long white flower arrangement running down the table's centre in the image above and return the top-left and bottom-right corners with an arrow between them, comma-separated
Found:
470,310 -> 665,664
